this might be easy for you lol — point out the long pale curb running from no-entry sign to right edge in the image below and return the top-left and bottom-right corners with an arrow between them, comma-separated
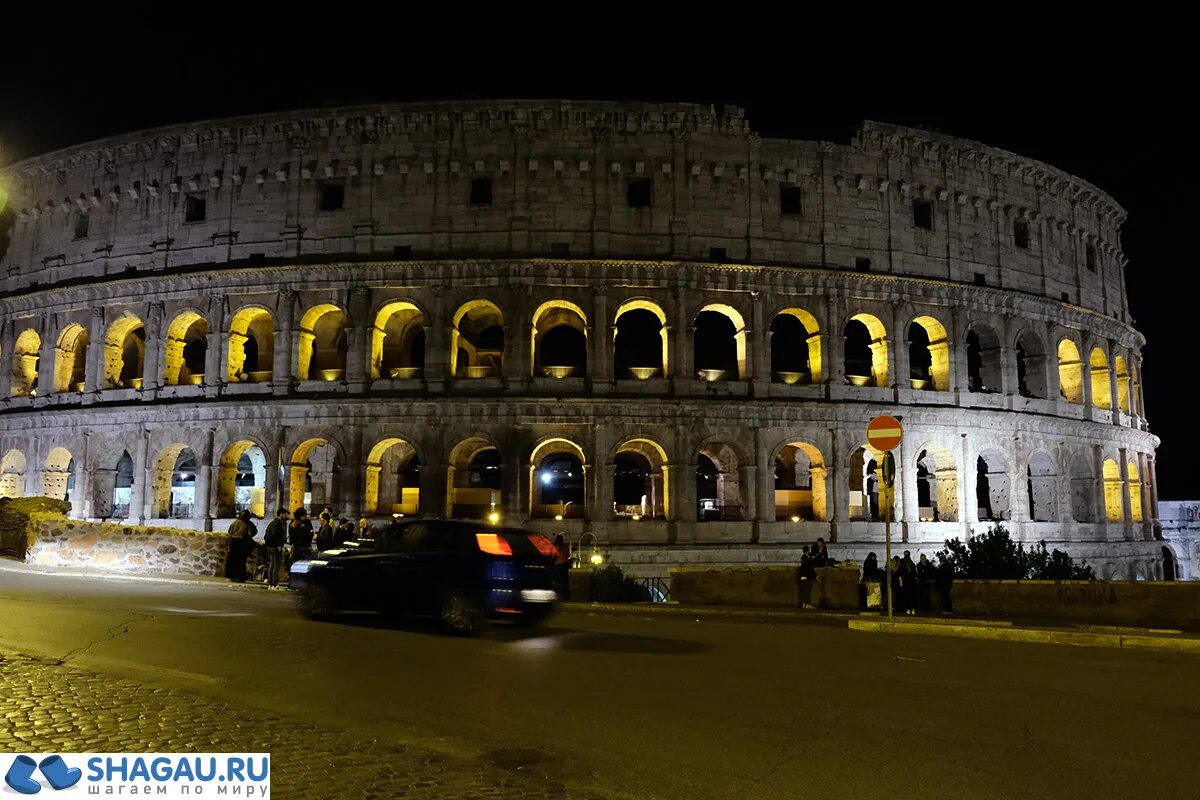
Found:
846,619 -> 1200,655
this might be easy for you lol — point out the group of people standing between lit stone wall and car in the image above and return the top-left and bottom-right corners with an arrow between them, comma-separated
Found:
226,505 -> 374,589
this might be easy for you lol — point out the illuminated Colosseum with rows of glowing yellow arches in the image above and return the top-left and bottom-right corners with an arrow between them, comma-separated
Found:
0,101 -> 1162,578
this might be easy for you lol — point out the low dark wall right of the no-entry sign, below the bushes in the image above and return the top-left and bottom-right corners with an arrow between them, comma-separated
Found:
950,581 -> 1200,630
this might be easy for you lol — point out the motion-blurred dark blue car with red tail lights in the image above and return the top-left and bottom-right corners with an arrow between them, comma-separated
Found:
288,519 -> 558,633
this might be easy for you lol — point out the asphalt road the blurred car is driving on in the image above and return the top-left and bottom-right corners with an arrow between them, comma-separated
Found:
0,571 -> 1200,800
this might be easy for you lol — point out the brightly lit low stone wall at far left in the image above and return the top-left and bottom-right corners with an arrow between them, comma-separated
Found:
25,512 -> 229,576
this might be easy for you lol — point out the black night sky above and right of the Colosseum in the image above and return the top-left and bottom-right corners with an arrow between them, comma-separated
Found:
0,9 -> 1200,499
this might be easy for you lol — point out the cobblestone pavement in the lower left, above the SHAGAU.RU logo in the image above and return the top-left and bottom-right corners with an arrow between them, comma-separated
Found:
0,654 -> 614,800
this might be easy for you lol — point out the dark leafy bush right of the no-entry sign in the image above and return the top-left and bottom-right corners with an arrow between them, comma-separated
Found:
937,525 -> 1096,581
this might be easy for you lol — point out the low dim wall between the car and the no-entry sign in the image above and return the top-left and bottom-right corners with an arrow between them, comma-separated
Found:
671,566 -> 858,609
